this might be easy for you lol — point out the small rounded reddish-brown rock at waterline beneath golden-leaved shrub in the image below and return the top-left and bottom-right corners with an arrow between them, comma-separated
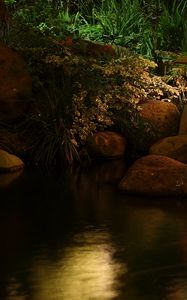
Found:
88,131 -> 126,158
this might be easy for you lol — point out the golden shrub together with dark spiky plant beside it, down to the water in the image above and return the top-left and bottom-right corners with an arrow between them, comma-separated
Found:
0,36 -> 187,166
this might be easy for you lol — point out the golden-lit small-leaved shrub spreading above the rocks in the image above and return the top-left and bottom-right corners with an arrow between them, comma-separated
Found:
32,45 -> 180,151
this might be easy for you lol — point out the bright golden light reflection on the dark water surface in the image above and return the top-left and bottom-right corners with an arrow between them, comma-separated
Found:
27,231 -> 127,300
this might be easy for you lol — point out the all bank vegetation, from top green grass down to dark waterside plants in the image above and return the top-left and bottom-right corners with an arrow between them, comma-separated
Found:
0,0 -> 187,165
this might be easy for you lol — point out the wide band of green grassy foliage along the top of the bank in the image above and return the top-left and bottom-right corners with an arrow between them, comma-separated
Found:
7,0 -> 187,58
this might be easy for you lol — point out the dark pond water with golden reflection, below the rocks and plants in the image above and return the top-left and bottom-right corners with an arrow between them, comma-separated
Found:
0,162 -> 187,300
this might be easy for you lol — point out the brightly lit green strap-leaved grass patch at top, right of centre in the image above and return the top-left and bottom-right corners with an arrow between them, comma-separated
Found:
73,0 -> 152,57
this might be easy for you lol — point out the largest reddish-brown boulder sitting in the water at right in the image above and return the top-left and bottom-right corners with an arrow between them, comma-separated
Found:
119,155 -> 187,196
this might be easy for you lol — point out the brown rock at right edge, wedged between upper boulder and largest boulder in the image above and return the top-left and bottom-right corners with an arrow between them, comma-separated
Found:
149,135 -> 187,163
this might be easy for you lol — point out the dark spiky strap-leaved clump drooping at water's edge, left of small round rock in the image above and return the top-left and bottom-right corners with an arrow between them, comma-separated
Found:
16,115 -> 79,167
